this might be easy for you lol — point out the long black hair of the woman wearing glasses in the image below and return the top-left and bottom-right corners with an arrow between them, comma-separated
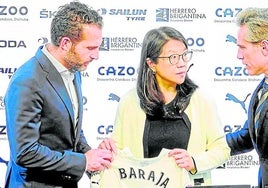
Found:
137,27 -> 198,116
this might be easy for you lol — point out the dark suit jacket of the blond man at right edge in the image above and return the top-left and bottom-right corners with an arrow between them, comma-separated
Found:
226,79 -> 268,188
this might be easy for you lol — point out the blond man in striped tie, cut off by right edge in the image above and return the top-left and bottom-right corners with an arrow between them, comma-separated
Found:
226,8 -> 268,188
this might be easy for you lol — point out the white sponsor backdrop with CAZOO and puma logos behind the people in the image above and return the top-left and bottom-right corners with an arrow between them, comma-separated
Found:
0,0 -> 267,187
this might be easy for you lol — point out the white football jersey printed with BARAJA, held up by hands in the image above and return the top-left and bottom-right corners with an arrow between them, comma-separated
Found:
91,148 -> 190,188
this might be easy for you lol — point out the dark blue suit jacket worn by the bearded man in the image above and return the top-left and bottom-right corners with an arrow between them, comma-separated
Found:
5,47 -> 90,188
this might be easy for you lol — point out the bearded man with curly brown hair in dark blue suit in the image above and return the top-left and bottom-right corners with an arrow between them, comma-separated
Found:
5,2 -> 112,188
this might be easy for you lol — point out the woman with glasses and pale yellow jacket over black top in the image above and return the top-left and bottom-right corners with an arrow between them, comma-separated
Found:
99,27 -> 230,185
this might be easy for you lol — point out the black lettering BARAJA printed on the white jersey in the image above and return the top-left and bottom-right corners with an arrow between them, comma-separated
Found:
118,167 -> 169,187
